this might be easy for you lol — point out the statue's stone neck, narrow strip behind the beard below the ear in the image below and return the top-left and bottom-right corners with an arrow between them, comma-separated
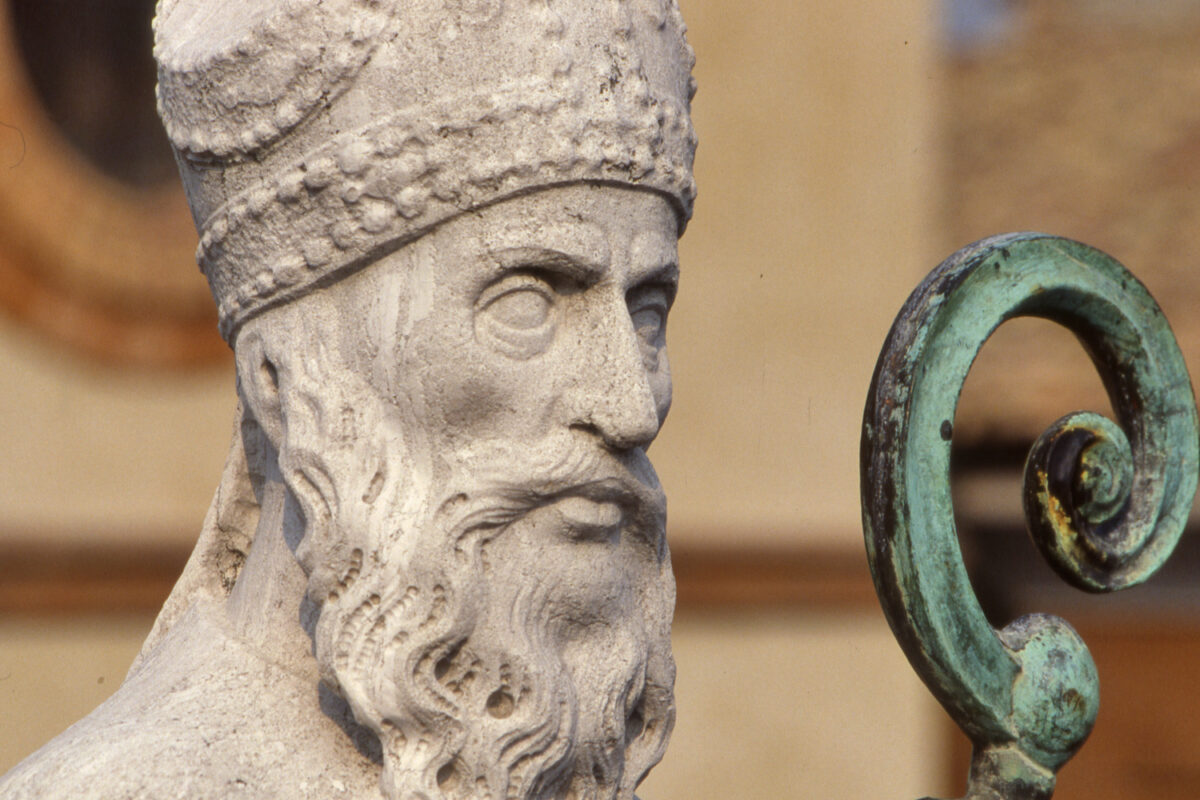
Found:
227,453 -> 318,681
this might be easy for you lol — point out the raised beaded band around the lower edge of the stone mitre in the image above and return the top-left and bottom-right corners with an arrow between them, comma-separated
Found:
197,71 -> 695,342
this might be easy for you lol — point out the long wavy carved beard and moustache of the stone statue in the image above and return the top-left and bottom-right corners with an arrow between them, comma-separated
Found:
281,376 -> 674,800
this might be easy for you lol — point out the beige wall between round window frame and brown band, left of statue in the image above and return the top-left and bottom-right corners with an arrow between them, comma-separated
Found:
0,318 -> 235,546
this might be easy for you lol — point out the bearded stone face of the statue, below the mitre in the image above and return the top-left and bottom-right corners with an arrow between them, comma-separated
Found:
255,186 -> 677,800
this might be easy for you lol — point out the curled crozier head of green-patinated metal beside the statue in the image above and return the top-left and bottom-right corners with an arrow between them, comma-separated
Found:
862,234 -> 1200,800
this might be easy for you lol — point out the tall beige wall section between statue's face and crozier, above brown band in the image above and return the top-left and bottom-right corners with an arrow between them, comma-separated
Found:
653,0 -> 942,548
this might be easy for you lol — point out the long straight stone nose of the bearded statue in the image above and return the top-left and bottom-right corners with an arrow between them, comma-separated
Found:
571,302 -> 660,450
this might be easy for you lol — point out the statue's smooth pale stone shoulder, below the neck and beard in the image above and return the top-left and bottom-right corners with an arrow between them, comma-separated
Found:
0,604 -> 379,800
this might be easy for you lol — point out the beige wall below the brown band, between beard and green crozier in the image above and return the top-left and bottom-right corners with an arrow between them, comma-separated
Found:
640,613 -> 950,800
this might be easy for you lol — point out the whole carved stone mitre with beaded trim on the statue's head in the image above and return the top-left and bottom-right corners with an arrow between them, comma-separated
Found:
155,0 -> 696,343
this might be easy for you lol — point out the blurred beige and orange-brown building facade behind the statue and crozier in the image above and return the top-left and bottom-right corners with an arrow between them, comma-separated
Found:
0,0 -> 1200,800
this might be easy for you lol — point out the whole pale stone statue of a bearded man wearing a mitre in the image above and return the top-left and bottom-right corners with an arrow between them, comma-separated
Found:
0,0 -> 695,800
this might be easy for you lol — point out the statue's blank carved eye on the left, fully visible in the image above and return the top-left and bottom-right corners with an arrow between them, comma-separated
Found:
475,272 -> 557,359
